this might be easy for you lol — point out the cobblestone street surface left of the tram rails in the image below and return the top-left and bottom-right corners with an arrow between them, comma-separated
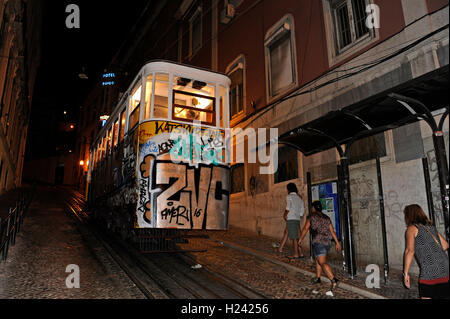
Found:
0,187 -> 144,299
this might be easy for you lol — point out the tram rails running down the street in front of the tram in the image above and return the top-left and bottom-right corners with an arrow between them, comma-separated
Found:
61,191 -> 267,299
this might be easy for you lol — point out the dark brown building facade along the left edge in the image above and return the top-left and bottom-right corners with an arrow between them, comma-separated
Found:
0,0 -> 41,193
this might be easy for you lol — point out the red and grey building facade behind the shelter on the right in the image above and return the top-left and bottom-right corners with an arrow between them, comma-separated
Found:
76,0 -> 449,271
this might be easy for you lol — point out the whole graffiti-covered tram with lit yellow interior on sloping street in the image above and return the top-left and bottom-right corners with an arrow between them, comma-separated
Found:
88,61 -> 230,252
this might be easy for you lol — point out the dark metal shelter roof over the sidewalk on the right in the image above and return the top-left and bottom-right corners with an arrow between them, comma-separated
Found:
278,65 -> 449,156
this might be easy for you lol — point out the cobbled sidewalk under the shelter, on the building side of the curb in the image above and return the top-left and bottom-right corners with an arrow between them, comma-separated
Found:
208,227 -> 419,299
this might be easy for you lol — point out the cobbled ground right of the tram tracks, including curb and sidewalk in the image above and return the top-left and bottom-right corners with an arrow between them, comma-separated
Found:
189,227 -> 418,299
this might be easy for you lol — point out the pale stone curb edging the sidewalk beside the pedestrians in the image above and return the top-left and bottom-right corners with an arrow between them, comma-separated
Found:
210,238 -> 389,299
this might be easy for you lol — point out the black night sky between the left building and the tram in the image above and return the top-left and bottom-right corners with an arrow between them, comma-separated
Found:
26,0 -> 149,160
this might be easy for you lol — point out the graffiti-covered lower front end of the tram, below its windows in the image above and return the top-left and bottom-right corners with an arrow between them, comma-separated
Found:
136,121 -> 230,229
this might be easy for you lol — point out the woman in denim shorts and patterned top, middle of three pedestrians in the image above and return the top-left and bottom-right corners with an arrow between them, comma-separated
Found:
298,201 -> 342,291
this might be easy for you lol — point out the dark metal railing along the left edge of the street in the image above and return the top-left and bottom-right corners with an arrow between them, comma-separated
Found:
0,189 -> 34,261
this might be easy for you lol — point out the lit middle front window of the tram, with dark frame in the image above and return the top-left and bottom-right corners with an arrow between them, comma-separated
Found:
172,77 -> 216,126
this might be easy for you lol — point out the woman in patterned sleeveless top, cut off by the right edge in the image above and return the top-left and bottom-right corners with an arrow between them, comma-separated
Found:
403,204 -> 449,299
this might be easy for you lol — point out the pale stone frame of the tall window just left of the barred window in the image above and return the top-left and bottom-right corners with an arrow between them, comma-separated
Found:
264,14 -> 298,102
